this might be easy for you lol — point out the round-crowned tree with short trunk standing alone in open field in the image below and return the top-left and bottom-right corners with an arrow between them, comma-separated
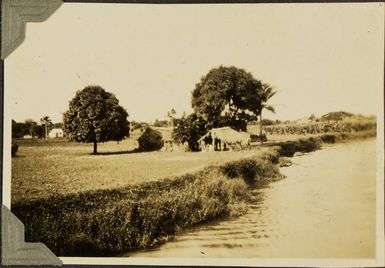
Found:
63,85 -> 130,154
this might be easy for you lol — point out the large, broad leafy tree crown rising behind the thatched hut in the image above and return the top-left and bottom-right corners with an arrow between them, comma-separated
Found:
192,66 -> 262,130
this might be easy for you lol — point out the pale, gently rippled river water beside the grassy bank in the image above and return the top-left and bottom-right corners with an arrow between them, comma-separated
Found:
127,139 -> 376,258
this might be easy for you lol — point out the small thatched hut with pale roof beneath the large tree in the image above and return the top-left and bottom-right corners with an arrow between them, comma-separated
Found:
198,127 -> 250,152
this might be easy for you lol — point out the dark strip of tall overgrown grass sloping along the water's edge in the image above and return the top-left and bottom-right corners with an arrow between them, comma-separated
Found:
12,129 -> 376,256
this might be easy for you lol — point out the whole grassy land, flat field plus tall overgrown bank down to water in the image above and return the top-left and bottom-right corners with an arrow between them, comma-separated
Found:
11,127 -> 376,256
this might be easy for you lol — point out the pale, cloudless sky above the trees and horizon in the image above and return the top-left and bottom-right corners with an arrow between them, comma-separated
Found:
5,3 -> 384,122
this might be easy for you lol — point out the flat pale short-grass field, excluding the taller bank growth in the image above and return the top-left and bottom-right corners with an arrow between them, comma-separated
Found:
11,132 -> 268,203
